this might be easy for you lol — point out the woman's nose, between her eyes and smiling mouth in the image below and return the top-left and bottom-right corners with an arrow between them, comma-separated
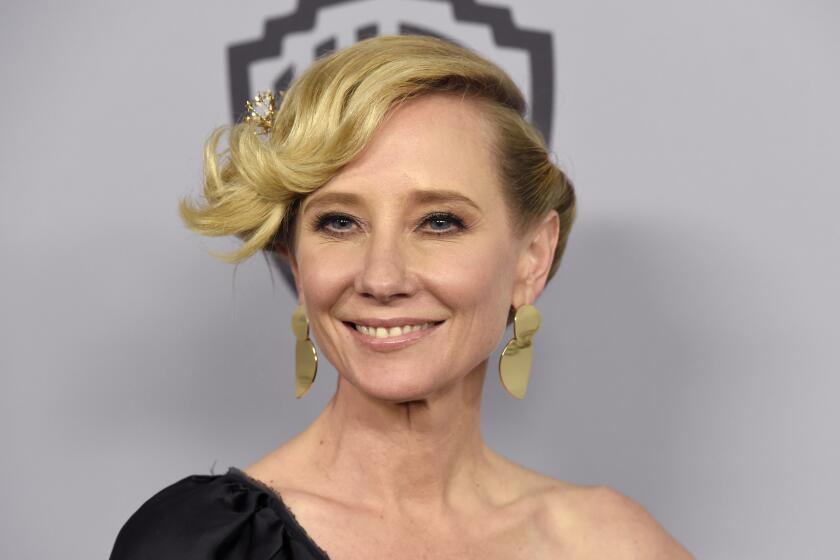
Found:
355,232 -> 415,303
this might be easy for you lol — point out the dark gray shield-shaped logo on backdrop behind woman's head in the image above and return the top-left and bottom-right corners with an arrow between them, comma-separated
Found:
228,0 -> 554,143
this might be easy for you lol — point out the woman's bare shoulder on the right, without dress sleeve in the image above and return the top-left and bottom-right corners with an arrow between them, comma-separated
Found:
543,482 -> 692,560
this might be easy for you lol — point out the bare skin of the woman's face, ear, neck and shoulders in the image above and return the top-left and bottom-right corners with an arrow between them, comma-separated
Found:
245,95 -> 690,560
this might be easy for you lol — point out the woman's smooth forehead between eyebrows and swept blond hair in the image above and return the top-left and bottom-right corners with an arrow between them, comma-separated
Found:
304,94 -> 500,208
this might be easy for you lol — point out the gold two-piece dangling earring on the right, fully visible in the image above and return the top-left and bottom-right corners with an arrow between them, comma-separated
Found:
499,303 -> 540,399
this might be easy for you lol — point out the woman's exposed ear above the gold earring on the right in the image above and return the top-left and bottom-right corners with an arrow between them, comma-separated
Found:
512,210 -> 560,309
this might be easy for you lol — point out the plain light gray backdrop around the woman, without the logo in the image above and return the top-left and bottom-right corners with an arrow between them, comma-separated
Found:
0,0 -> 840,559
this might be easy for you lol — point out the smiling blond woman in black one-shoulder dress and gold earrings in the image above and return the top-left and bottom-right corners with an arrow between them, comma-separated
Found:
111,37 -> 689,560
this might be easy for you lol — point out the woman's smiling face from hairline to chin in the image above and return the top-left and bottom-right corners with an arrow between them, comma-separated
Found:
292,95 -> 544,402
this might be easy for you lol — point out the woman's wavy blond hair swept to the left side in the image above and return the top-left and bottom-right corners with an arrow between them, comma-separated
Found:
179,35 -> 575,278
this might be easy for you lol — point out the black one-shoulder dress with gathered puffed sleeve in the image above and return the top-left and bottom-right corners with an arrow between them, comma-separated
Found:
111,467 -> 329,560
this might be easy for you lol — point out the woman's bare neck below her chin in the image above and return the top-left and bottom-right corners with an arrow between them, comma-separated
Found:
302,362 -> 486,508
